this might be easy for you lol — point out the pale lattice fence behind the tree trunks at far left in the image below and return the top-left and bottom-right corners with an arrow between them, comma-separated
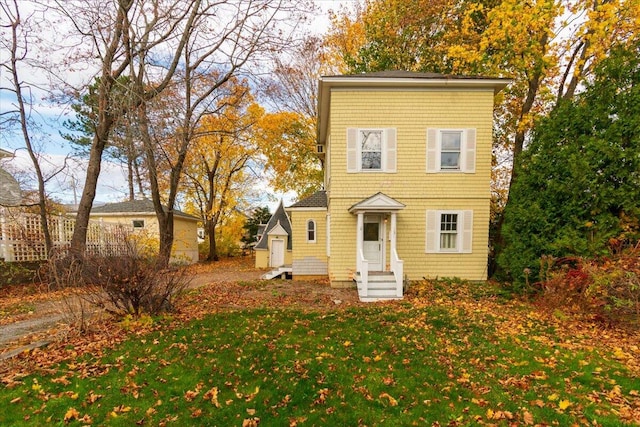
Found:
0,211 -> 131,262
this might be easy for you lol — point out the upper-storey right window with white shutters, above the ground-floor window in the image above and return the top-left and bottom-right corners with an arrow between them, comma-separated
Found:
427,128 -> 476,173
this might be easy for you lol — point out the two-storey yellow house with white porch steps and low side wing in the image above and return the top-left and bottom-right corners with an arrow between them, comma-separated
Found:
258,71 -> 510,300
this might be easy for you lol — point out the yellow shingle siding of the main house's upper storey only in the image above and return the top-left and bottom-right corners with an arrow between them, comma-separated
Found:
329,90 -> 493,199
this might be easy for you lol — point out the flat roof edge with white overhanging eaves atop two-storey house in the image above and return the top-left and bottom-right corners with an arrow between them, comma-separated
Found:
318,71 -> 512,145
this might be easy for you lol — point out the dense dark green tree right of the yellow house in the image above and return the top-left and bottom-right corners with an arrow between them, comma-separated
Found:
499,42 -> 640,288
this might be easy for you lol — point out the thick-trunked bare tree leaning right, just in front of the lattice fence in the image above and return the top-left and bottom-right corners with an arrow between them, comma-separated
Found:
54,0 -> 201,257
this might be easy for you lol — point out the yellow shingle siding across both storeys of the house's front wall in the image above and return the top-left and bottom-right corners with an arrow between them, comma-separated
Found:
325,89 -> 493,284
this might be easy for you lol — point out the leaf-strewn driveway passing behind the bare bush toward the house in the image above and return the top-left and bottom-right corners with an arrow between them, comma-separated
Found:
0,257 -> 358,361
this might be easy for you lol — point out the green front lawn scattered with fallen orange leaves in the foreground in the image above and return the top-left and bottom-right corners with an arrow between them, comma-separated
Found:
0,282 -> 640,426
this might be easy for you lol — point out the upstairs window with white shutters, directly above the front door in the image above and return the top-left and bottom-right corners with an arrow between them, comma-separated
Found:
347,128 -> 396,173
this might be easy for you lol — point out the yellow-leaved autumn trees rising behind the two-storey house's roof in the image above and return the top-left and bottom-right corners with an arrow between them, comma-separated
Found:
325,0 -> 640,244
